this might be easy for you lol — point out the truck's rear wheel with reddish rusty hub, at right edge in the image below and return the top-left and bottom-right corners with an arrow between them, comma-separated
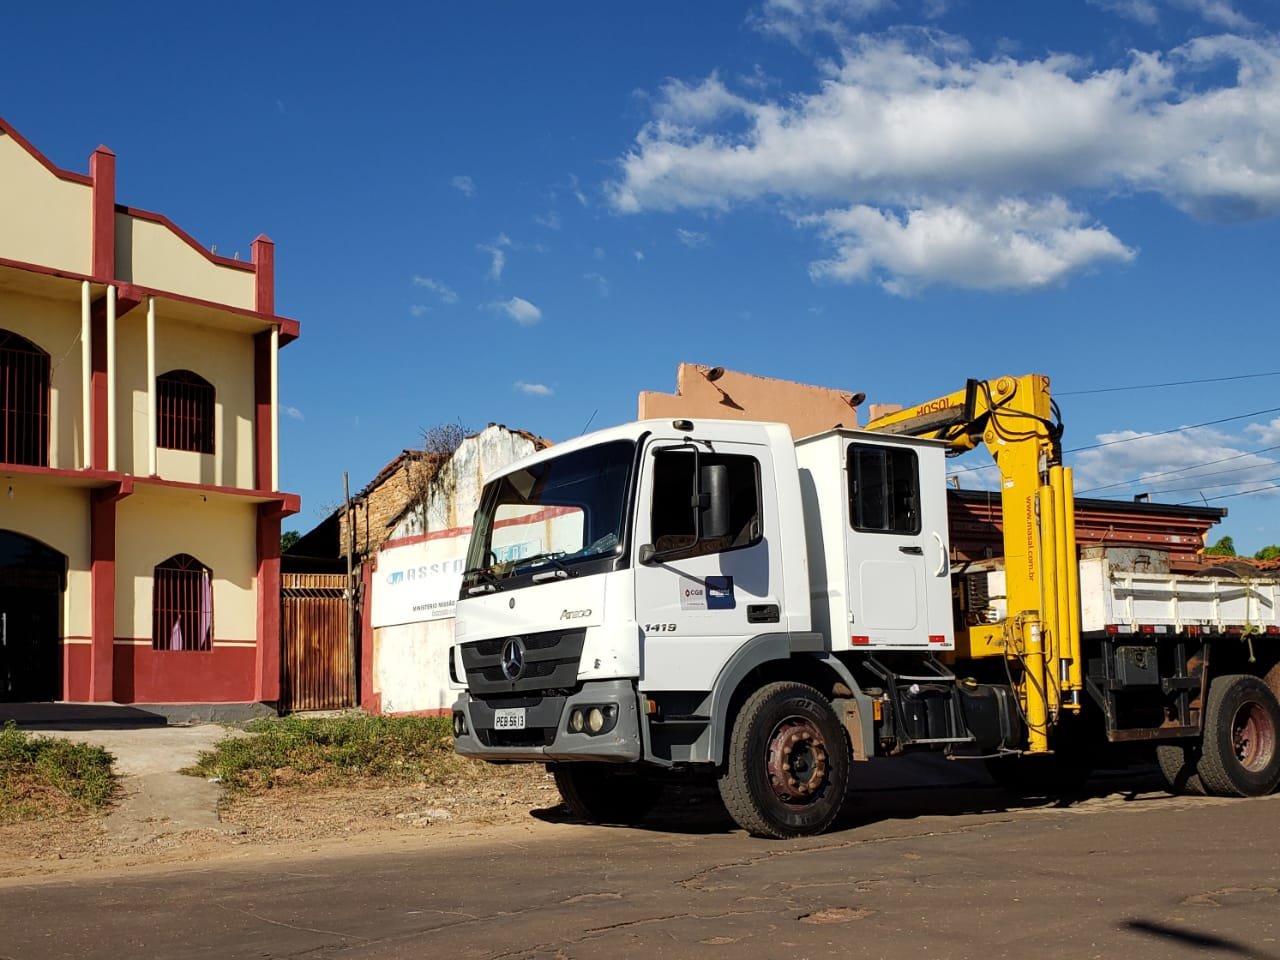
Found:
1196,673 -> 1280,796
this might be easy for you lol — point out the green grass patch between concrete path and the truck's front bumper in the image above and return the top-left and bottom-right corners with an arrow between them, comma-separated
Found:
186,713 -> 468,790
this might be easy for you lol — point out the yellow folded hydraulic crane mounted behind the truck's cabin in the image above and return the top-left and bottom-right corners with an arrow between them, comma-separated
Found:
865,374 -> 1083,753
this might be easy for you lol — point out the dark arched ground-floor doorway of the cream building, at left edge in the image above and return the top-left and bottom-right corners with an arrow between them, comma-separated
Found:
0,530 -> 67,703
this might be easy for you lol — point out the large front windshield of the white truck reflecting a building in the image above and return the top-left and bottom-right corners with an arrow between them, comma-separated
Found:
462,440 -> 635,595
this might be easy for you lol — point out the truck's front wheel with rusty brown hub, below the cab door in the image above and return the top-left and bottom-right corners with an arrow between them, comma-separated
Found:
719,682 -> 850,840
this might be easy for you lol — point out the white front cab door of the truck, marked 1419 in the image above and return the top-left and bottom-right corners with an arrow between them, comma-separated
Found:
635,440 -> 786,690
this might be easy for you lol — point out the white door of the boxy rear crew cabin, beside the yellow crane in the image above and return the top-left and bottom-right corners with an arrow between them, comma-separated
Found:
845,442 -> 954,649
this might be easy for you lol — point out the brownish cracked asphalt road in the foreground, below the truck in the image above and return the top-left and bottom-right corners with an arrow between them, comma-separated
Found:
0,781 -> 1280,960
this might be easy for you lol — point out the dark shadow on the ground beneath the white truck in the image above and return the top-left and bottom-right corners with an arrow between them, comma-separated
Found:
530,758 -> 1170,836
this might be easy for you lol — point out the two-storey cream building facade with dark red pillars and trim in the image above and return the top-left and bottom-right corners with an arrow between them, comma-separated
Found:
0,120 -> 298,703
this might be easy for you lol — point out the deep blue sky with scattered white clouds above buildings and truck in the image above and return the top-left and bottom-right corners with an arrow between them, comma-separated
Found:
0,0 -> 1280,552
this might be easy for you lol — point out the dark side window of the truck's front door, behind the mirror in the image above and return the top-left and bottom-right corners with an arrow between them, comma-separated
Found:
650,448 -> 763,559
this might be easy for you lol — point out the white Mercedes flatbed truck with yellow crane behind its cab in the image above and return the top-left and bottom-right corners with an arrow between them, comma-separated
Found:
451,375 -> 1280,837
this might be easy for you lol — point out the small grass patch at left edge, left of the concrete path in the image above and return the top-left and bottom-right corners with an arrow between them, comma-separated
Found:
0,722 -> 115,823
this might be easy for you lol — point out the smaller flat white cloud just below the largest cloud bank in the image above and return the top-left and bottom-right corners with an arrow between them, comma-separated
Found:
810,198 -> 1134,296
